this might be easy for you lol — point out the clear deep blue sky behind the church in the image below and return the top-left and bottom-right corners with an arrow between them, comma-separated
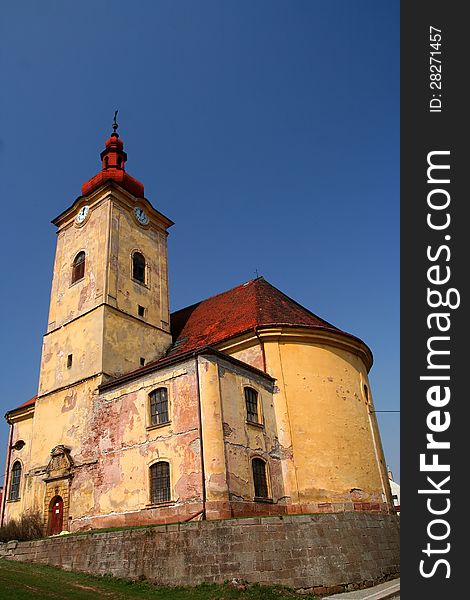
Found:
0,0 -> 399,479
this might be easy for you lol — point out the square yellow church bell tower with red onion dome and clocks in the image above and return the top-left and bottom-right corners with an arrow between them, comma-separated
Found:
39,117 -> 173,397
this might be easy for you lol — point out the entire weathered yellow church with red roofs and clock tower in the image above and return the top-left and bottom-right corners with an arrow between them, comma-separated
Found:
1,122 -> 393,535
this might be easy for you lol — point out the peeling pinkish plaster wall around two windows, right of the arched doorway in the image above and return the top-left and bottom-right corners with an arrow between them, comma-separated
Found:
70,363 -> 202,528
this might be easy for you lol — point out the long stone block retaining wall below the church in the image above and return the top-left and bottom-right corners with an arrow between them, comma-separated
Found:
0,512 -> 399,593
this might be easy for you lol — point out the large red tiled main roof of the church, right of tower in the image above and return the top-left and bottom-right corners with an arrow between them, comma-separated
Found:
167,277 -> 340,356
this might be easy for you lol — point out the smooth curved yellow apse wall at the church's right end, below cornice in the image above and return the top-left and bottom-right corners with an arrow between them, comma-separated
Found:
272,341 -> 386,503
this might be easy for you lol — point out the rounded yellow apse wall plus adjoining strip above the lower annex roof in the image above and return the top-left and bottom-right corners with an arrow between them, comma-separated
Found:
226,330 -> 391,505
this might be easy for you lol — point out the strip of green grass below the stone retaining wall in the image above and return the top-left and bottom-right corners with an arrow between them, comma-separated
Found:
0,560 -> 315,600
